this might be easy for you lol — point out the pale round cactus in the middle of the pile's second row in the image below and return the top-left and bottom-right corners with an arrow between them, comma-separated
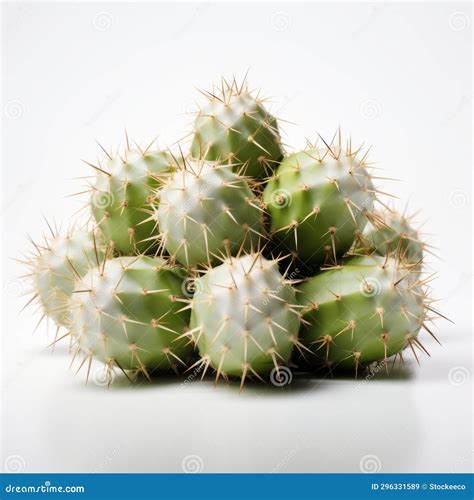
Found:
156,160 -> 262,267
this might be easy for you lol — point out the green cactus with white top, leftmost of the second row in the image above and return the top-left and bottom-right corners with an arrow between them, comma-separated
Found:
90,144 -> 176,255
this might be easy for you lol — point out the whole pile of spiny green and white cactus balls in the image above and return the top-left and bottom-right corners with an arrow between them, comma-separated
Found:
21,79 -> 441,388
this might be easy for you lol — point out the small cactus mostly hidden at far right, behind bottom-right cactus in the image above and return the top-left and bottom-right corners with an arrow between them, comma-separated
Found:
353,208 -> 427,271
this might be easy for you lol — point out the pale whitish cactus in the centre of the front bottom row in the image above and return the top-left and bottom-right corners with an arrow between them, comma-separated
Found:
189,253 -> 301,388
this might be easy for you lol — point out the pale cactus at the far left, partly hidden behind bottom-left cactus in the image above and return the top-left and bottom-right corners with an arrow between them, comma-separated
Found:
26,226 -> 106,327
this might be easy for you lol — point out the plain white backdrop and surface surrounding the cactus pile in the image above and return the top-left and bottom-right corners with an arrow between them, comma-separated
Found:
2,2 -> 473,472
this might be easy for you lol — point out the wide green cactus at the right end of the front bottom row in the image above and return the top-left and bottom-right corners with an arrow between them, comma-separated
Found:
297,255 -> 436,374
